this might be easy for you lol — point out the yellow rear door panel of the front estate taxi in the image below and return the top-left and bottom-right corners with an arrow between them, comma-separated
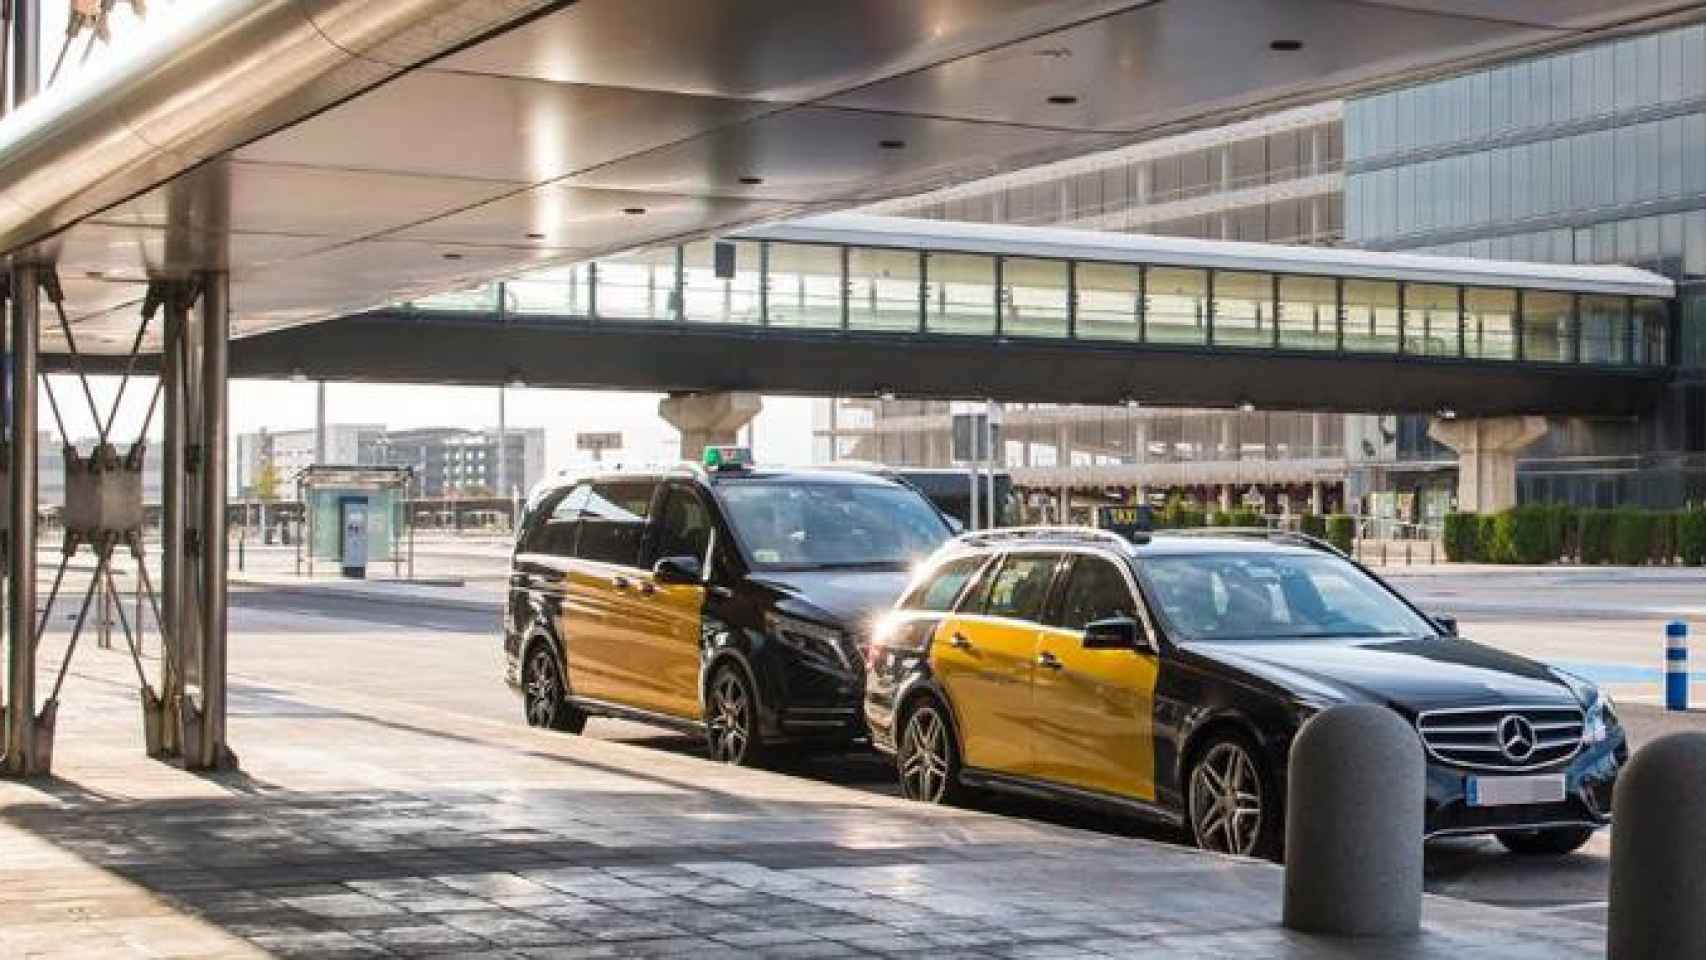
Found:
930,616 -> 1037,774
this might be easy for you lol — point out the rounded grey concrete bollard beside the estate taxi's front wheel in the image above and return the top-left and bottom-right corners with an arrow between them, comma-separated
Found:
1285,704 -> 1426,936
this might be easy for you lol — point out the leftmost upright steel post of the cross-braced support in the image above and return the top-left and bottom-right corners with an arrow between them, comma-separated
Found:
3,260 -> 43,776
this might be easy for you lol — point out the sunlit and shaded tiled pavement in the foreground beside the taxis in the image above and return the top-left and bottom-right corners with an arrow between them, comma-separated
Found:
0,603 -> 1602,960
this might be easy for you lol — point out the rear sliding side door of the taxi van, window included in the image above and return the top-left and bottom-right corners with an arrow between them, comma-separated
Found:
568,479 -> 659,709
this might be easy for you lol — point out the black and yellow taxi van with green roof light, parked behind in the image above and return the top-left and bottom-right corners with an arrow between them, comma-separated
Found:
503,452 -> 952,764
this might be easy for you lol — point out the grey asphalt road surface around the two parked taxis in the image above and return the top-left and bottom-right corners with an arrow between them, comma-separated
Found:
196,575 -> 1706,922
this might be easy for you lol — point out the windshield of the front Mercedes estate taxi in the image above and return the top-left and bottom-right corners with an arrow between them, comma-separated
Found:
1143,552 -> 1435,641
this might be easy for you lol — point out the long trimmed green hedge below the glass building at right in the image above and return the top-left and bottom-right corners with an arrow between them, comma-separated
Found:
1443,505 -> 1706,566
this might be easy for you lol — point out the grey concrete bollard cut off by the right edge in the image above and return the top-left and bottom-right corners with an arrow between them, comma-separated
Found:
1605,732 -> 1706,960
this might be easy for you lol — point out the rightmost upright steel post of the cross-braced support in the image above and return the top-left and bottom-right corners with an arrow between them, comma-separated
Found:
186,273 -> 235,767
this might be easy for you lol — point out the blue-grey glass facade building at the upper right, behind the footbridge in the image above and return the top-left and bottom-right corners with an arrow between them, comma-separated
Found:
1344,24 -> 1706,506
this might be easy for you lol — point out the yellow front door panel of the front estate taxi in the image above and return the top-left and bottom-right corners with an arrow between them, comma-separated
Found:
1030,627 -> 1160,800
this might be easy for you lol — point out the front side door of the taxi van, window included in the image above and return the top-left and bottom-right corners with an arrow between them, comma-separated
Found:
631,483 -> 711,720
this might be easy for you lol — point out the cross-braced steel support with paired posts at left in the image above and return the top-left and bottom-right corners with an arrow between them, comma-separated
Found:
5,266 -> 235,774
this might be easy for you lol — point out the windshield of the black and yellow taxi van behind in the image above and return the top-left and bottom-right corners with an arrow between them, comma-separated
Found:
717,481 -> 950,570
